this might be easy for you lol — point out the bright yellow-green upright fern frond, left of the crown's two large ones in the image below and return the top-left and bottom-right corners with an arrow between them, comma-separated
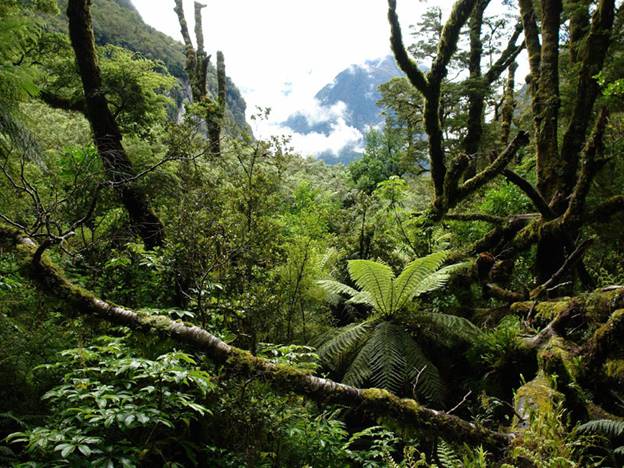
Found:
349,260 -> 394,315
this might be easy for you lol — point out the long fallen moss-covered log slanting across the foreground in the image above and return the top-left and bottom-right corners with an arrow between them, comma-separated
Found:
0,225 -> 513,451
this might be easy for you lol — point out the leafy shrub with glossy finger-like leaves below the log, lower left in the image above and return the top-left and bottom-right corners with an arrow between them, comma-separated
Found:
8,337 -> 215,466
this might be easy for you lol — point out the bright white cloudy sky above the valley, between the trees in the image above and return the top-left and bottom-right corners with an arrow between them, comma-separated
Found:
132,0 -> 510,154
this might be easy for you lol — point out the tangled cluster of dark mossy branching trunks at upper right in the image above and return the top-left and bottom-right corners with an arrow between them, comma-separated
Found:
388,0 -> 624,285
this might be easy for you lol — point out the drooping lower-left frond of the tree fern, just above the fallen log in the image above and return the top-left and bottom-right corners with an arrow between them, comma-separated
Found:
318,321 -> 375,371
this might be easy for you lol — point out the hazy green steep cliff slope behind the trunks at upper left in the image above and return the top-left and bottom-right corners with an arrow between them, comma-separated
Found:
52,0 -> 248,133
